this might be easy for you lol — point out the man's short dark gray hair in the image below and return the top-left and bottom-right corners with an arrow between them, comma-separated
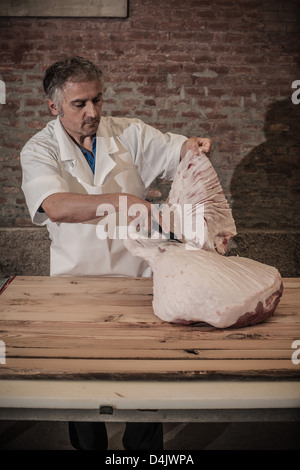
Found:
43,56 -> 103,105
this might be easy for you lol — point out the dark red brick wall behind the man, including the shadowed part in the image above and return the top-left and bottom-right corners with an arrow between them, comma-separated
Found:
0,0 -> 300,275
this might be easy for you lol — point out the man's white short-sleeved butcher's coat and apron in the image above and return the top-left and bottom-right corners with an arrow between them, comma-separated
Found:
21,117 -> 186,276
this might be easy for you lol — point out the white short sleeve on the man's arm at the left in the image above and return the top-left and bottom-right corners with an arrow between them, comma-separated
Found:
21,139 -> 69,225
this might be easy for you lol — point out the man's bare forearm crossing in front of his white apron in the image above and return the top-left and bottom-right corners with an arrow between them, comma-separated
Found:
42,193 -> 139,223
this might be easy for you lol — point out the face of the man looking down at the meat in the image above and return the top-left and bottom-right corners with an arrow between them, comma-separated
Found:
48,80 -> 102,142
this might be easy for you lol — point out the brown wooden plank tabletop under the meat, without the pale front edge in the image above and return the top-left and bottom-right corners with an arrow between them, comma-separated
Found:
0,277 -> 300,380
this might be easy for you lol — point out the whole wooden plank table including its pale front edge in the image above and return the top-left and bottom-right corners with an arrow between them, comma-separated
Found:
0,277 -> 300,421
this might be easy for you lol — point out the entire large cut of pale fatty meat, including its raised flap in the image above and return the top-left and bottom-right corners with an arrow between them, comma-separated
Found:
124,149 -> 283,328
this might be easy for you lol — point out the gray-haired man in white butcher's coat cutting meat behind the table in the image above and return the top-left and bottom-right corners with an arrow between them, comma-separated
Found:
21,57 -> 211,450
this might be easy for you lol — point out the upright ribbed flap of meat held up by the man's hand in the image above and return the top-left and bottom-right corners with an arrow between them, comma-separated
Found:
163,150 -> 236,254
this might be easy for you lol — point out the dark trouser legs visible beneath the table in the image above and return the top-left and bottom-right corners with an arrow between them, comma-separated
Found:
69,422 -> 163,450
